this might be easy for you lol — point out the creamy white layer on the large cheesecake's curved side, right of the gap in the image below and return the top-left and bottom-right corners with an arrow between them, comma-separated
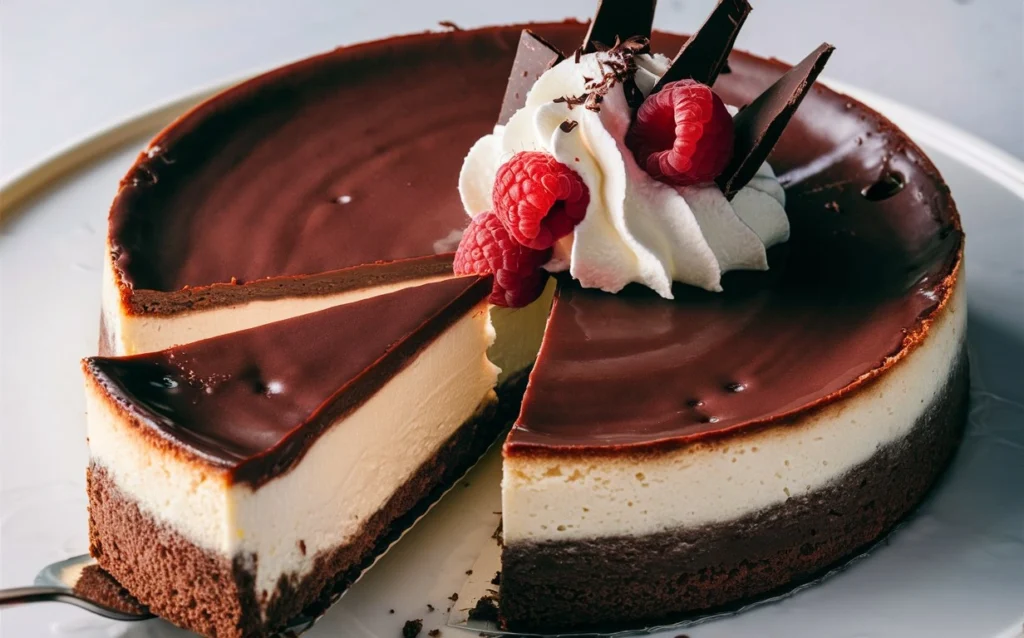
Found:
502,284 -> 967,545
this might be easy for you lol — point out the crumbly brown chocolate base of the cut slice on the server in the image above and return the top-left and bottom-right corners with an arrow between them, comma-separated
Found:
87,373 -> 527,637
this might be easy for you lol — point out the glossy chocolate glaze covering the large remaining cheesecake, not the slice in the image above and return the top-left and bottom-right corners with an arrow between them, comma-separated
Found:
111,23 -> 963,453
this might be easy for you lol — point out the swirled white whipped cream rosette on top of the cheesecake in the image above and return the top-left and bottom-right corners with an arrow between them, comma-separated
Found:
459,53 -> 790,299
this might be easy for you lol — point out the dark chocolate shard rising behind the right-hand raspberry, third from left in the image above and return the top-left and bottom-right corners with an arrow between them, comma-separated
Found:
651,0 -> 751,93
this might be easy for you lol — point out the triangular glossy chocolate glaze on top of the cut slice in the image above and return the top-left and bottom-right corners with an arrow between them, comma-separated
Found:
84,277 -> 492,484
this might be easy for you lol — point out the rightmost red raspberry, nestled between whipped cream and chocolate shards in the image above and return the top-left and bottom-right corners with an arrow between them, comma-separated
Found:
626,80 -> 735,186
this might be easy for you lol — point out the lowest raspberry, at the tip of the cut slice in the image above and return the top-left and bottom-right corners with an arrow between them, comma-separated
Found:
455,211 -> 551,308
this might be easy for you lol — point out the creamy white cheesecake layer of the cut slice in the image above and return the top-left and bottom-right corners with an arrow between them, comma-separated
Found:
86,304 -> 498,601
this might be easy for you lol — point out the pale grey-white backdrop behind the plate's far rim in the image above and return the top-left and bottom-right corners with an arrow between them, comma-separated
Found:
0,0 -> 1024,181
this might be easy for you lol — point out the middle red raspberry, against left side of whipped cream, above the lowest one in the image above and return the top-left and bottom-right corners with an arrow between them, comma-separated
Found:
492,152 -> 590,250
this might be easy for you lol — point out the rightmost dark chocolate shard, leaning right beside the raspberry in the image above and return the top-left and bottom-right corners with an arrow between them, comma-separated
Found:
716,44 -> 836,199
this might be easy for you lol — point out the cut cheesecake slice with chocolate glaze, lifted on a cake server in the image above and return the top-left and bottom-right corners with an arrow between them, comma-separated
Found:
83,278 -> 505,636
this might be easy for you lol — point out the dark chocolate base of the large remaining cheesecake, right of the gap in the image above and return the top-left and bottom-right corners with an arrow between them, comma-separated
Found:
500,349 -> 969,633
